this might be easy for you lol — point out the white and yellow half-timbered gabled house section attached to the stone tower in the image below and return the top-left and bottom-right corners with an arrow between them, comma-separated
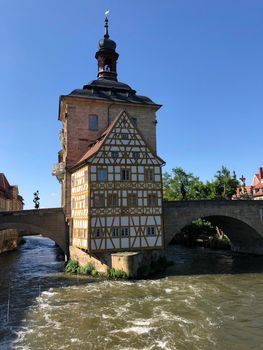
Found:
71,111 -> 164,252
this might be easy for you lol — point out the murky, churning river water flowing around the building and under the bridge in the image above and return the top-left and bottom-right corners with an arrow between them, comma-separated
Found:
0,237 -> 263,350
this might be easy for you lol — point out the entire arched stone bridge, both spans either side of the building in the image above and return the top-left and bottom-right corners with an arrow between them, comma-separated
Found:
0,200 -> 263,256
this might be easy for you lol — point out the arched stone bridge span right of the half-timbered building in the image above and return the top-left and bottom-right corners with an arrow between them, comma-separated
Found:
163,200 -> 263,254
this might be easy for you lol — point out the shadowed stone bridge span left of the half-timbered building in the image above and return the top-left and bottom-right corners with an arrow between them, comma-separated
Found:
0,208 -> 69,256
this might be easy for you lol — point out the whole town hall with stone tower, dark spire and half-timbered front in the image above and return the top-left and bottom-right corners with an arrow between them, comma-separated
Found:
53,18 -> 164,254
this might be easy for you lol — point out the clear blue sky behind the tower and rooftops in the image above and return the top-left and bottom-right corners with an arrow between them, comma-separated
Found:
0,0 -> 263,208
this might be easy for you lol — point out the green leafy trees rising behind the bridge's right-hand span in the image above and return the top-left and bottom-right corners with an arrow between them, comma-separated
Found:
163,166 -> 239,201
